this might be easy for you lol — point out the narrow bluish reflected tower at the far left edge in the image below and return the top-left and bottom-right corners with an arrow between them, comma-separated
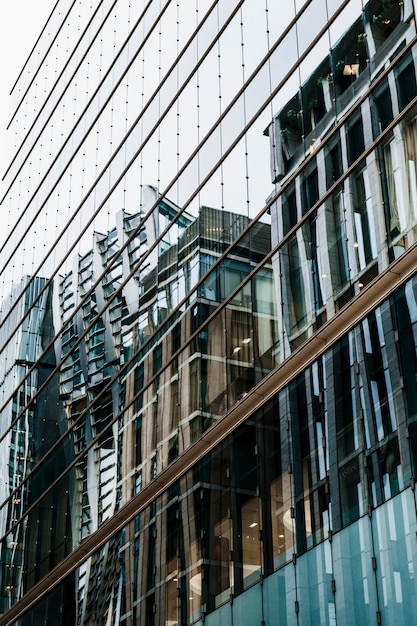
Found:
0,277 -> 71,612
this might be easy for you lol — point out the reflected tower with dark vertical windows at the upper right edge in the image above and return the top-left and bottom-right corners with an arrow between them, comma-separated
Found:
268,1 -> 417,351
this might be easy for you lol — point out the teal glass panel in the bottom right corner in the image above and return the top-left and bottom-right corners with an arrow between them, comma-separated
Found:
372,489 -> 417,624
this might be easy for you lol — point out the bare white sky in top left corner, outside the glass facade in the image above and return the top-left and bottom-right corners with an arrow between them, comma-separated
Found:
0,0 -> 56,179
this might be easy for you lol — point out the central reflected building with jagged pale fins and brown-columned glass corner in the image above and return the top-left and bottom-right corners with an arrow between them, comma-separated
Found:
55,199 -> 276,624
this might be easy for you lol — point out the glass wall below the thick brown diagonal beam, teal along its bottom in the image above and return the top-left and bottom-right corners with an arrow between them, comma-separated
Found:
3,278 -> 417,626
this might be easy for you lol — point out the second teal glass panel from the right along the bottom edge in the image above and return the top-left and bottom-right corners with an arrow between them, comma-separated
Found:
332,517 -> 378,624
